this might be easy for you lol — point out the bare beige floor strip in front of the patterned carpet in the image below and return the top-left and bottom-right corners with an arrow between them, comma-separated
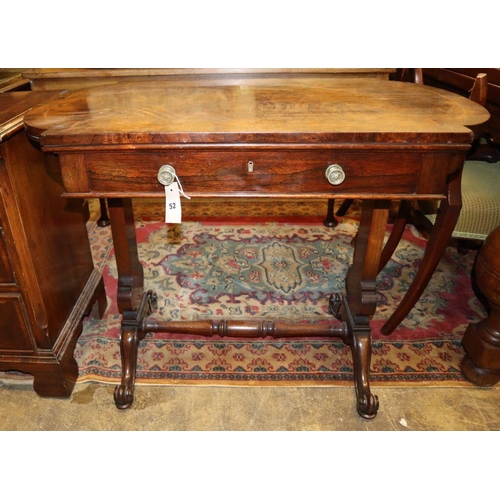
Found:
0,384 -> 500,431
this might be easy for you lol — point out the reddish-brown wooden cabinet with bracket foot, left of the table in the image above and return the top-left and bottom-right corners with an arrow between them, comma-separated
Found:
0,92 -> 106,397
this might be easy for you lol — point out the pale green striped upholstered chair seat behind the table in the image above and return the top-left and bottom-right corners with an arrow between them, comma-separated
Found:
419,161 -> 500,240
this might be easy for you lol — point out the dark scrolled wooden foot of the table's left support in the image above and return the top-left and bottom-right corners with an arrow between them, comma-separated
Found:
114,290 -> 157,410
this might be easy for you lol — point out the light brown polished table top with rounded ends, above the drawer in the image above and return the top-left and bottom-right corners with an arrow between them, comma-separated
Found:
24,79 -> 489,150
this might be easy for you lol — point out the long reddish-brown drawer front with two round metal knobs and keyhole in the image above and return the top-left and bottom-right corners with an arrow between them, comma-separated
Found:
82,149 -> 420,196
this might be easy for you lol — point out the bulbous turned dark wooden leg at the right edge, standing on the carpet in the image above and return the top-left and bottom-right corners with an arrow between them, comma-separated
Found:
460,226 -> 500,387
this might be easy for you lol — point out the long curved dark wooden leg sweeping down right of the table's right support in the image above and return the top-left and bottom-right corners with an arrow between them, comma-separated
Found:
381,176 -> 462,335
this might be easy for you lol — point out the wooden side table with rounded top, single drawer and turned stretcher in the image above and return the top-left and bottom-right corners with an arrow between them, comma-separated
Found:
24,78 -> 489,418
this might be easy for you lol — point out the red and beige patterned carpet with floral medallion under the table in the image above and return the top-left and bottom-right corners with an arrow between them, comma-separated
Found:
75,200 -> 485,386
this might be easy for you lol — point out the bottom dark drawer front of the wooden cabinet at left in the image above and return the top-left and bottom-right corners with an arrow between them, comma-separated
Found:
0,293 -> 35,351
